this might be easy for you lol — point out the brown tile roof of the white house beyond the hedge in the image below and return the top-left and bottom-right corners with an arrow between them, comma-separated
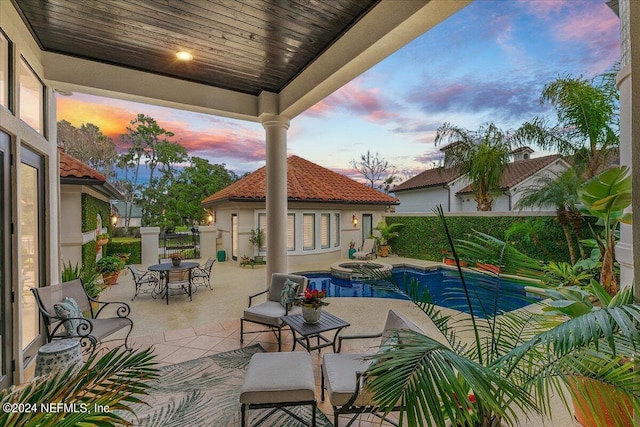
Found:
393,154 -> 560,193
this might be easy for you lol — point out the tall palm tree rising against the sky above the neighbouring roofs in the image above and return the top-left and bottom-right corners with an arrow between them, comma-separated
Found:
513,73 -> 619,179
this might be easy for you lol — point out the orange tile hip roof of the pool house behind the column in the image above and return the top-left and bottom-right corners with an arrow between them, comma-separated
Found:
202,156 -> 398,205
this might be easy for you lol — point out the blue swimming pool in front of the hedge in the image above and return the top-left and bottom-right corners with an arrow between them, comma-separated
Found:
303,267 -> 539,317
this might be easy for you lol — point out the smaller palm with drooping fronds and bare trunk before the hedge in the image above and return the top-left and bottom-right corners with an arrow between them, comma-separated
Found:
514,168 -> 586,264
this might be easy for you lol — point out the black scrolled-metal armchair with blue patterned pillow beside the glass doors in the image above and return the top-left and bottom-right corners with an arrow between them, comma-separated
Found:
31,279 -> 133,354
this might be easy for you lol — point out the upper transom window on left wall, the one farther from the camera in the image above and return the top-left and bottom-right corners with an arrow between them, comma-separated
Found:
19,58 -> 44,135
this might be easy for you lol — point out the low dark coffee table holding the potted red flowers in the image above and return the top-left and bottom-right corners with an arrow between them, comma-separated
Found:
282,310 -> 351,353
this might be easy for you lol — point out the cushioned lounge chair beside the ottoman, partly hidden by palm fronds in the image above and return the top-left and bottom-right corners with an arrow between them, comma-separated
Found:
321,310 -> 424,427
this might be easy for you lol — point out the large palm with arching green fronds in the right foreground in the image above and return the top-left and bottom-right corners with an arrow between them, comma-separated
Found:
365,208 -> 640,427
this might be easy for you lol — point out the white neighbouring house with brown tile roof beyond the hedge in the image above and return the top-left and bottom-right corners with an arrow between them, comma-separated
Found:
393,147 -> 570,213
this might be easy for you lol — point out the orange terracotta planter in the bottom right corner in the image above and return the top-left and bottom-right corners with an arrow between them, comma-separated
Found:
569,377 -> 633,427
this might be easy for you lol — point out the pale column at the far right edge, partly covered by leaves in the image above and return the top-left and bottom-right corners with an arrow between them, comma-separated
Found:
616,0 -> 638,287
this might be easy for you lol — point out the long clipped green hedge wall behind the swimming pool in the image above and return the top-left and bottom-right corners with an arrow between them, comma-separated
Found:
386,215 -> 572,262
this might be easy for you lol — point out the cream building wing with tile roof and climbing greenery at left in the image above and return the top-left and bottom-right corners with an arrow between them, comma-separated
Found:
59,148 -> 122,265
